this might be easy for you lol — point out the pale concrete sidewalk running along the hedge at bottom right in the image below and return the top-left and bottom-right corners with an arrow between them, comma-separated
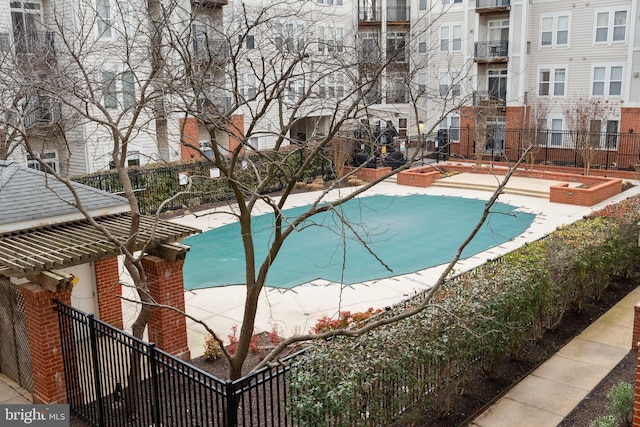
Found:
470,287 -> 640,427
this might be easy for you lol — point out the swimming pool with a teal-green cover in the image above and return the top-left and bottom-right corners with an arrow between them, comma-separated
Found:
184,194 -> 535,289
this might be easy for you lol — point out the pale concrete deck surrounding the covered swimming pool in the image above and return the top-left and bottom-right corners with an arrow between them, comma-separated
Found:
117,169 -> 640,357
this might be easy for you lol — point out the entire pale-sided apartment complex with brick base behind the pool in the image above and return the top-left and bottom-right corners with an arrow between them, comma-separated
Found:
0,0 -> 640,175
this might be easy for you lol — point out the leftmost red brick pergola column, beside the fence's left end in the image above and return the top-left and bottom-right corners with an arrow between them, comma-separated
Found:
18,283 -> 71,404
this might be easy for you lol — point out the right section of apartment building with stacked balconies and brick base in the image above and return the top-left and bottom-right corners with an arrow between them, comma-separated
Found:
357,0 -> 640,164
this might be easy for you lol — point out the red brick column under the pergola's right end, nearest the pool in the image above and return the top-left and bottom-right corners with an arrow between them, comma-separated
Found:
142,255 -> 191,360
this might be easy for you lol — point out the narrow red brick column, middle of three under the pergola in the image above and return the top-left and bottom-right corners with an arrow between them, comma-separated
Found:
95,257 -> 124,329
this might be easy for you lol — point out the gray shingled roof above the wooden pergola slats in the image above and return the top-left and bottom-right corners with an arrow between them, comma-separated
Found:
0,160 -> 128,232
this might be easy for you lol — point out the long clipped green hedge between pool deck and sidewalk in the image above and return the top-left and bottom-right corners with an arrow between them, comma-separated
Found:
290,198 -> 640,426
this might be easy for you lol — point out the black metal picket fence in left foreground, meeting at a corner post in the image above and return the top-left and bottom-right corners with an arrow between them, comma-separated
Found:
56,302 -> 297,427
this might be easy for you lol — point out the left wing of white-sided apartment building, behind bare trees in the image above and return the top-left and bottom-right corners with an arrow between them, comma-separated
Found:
0,0 -> 227,176
